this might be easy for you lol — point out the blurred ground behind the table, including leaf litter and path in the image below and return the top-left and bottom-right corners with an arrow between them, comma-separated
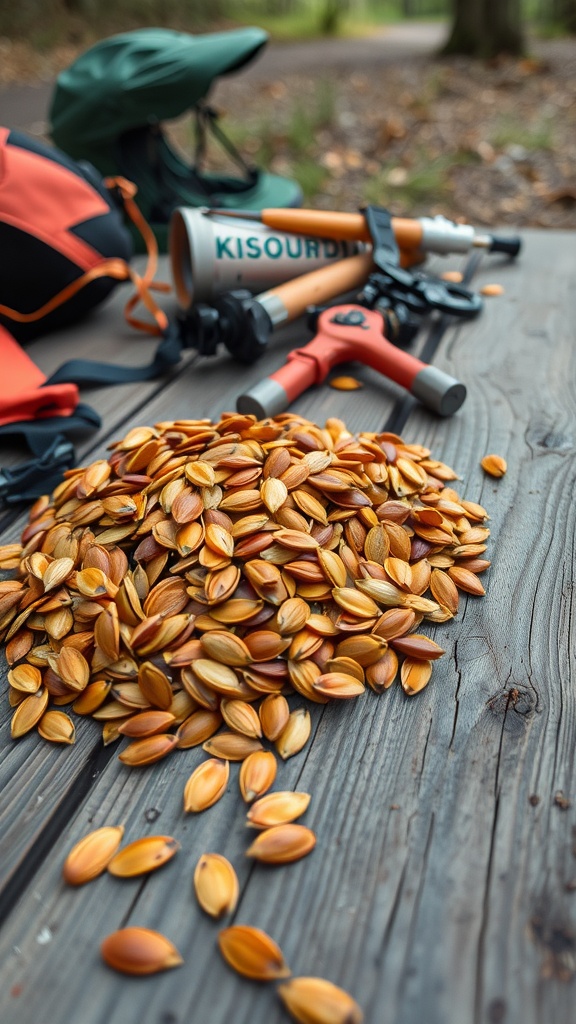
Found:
0,25 -> 576,229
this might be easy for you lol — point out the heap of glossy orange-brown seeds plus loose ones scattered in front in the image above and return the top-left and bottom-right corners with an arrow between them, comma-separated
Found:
0,413 -> 490,1021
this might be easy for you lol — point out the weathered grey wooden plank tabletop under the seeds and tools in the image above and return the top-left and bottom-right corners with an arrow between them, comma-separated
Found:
0,229 -> 576,1024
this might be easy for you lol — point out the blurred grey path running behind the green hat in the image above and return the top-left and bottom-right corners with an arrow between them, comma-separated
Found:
0,22 -> 447,135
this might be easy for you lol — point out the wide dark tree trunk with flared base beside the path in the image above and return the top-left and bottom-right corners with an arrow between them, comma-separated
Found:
443,0 -> 524,57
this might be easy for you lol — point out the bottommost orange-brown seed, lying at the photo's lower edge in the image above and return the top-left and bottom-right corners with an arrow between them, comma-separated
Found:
278,977 -> 364,1024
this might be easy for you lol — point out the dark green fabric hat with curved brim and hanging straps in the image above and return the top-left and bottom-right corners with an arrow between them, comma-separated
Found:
49,28 -> 302,249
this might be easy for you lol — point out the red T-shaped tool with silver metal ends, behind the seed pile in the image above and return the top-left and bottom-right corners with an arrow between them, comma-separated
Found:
237,305 -> 466,419
